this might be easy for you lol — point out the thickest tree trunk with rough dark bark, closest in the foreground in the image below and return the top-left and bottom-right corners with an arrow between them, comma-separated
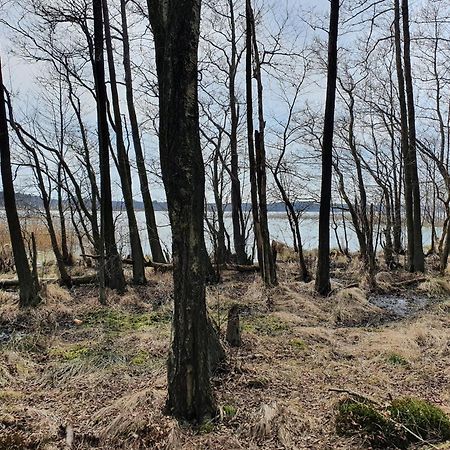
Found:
148,0 -> 218,422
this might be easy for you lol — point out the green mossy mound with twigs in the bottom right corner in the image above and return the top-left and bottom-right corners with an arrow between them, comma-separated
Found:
336,398 -> 450,449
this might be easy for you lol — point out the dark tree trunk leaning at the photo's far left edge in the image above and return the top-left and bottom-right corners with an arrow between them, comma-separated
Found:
0,60 -> 40,307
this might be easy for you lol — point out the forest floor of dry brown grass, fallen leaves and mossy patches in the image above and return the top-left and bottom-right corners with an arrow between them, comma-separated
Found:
0,258 -> 450,450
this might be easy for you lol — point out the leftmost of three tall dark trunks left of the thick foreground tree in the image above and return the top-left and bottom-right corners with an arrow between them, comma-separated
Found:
93,0 -> 125,292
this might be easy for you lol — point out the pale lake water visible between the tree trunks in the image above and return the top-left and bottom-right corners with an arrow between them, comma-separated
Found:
110,211 -> 440,255
